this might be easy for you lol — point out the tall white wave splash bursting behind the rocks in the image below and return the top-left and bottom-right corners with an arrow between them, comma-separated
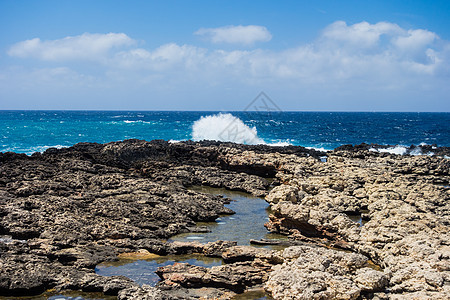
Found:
192,113 -> 266,145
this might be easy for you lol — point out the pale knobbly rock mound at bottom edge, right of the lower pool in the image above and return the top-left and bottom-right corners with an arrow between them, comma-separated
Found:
266,246 -> 389,299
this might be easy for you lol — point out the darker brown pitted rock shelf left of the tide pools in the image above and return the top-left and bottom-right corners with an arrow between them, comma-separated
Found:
0,140 -> 318,295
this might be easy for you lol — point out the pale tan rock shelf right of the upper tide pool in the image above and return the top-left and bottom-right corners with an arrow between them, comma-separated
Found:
266,149 -> 450,299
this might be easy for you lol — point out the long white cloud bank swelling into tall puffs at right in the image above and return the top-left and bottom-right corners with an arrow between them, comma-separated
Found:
110,21 -> 449,83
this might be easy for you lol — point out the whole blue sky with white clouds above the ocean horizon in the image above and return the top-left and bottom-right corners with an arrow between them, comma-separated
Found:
0,0 -> 450,112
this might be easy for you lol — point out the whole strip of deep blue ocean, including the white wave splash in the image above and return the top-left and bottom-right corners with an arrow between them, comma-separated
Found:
0,111 -> 450,154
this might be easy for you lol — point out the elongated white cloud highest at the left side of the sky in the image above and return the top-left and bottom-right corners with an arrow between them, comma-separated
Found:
8,33 -> 134,61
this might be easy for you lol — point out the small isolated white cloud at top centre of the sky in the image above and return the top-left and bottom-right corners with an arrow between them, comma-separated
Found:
194,25 -> 272,46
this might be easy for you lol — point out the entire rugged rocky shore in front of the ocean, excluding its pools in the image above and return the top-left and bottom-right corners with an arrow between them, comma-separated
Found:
0,140 -> 450,299
